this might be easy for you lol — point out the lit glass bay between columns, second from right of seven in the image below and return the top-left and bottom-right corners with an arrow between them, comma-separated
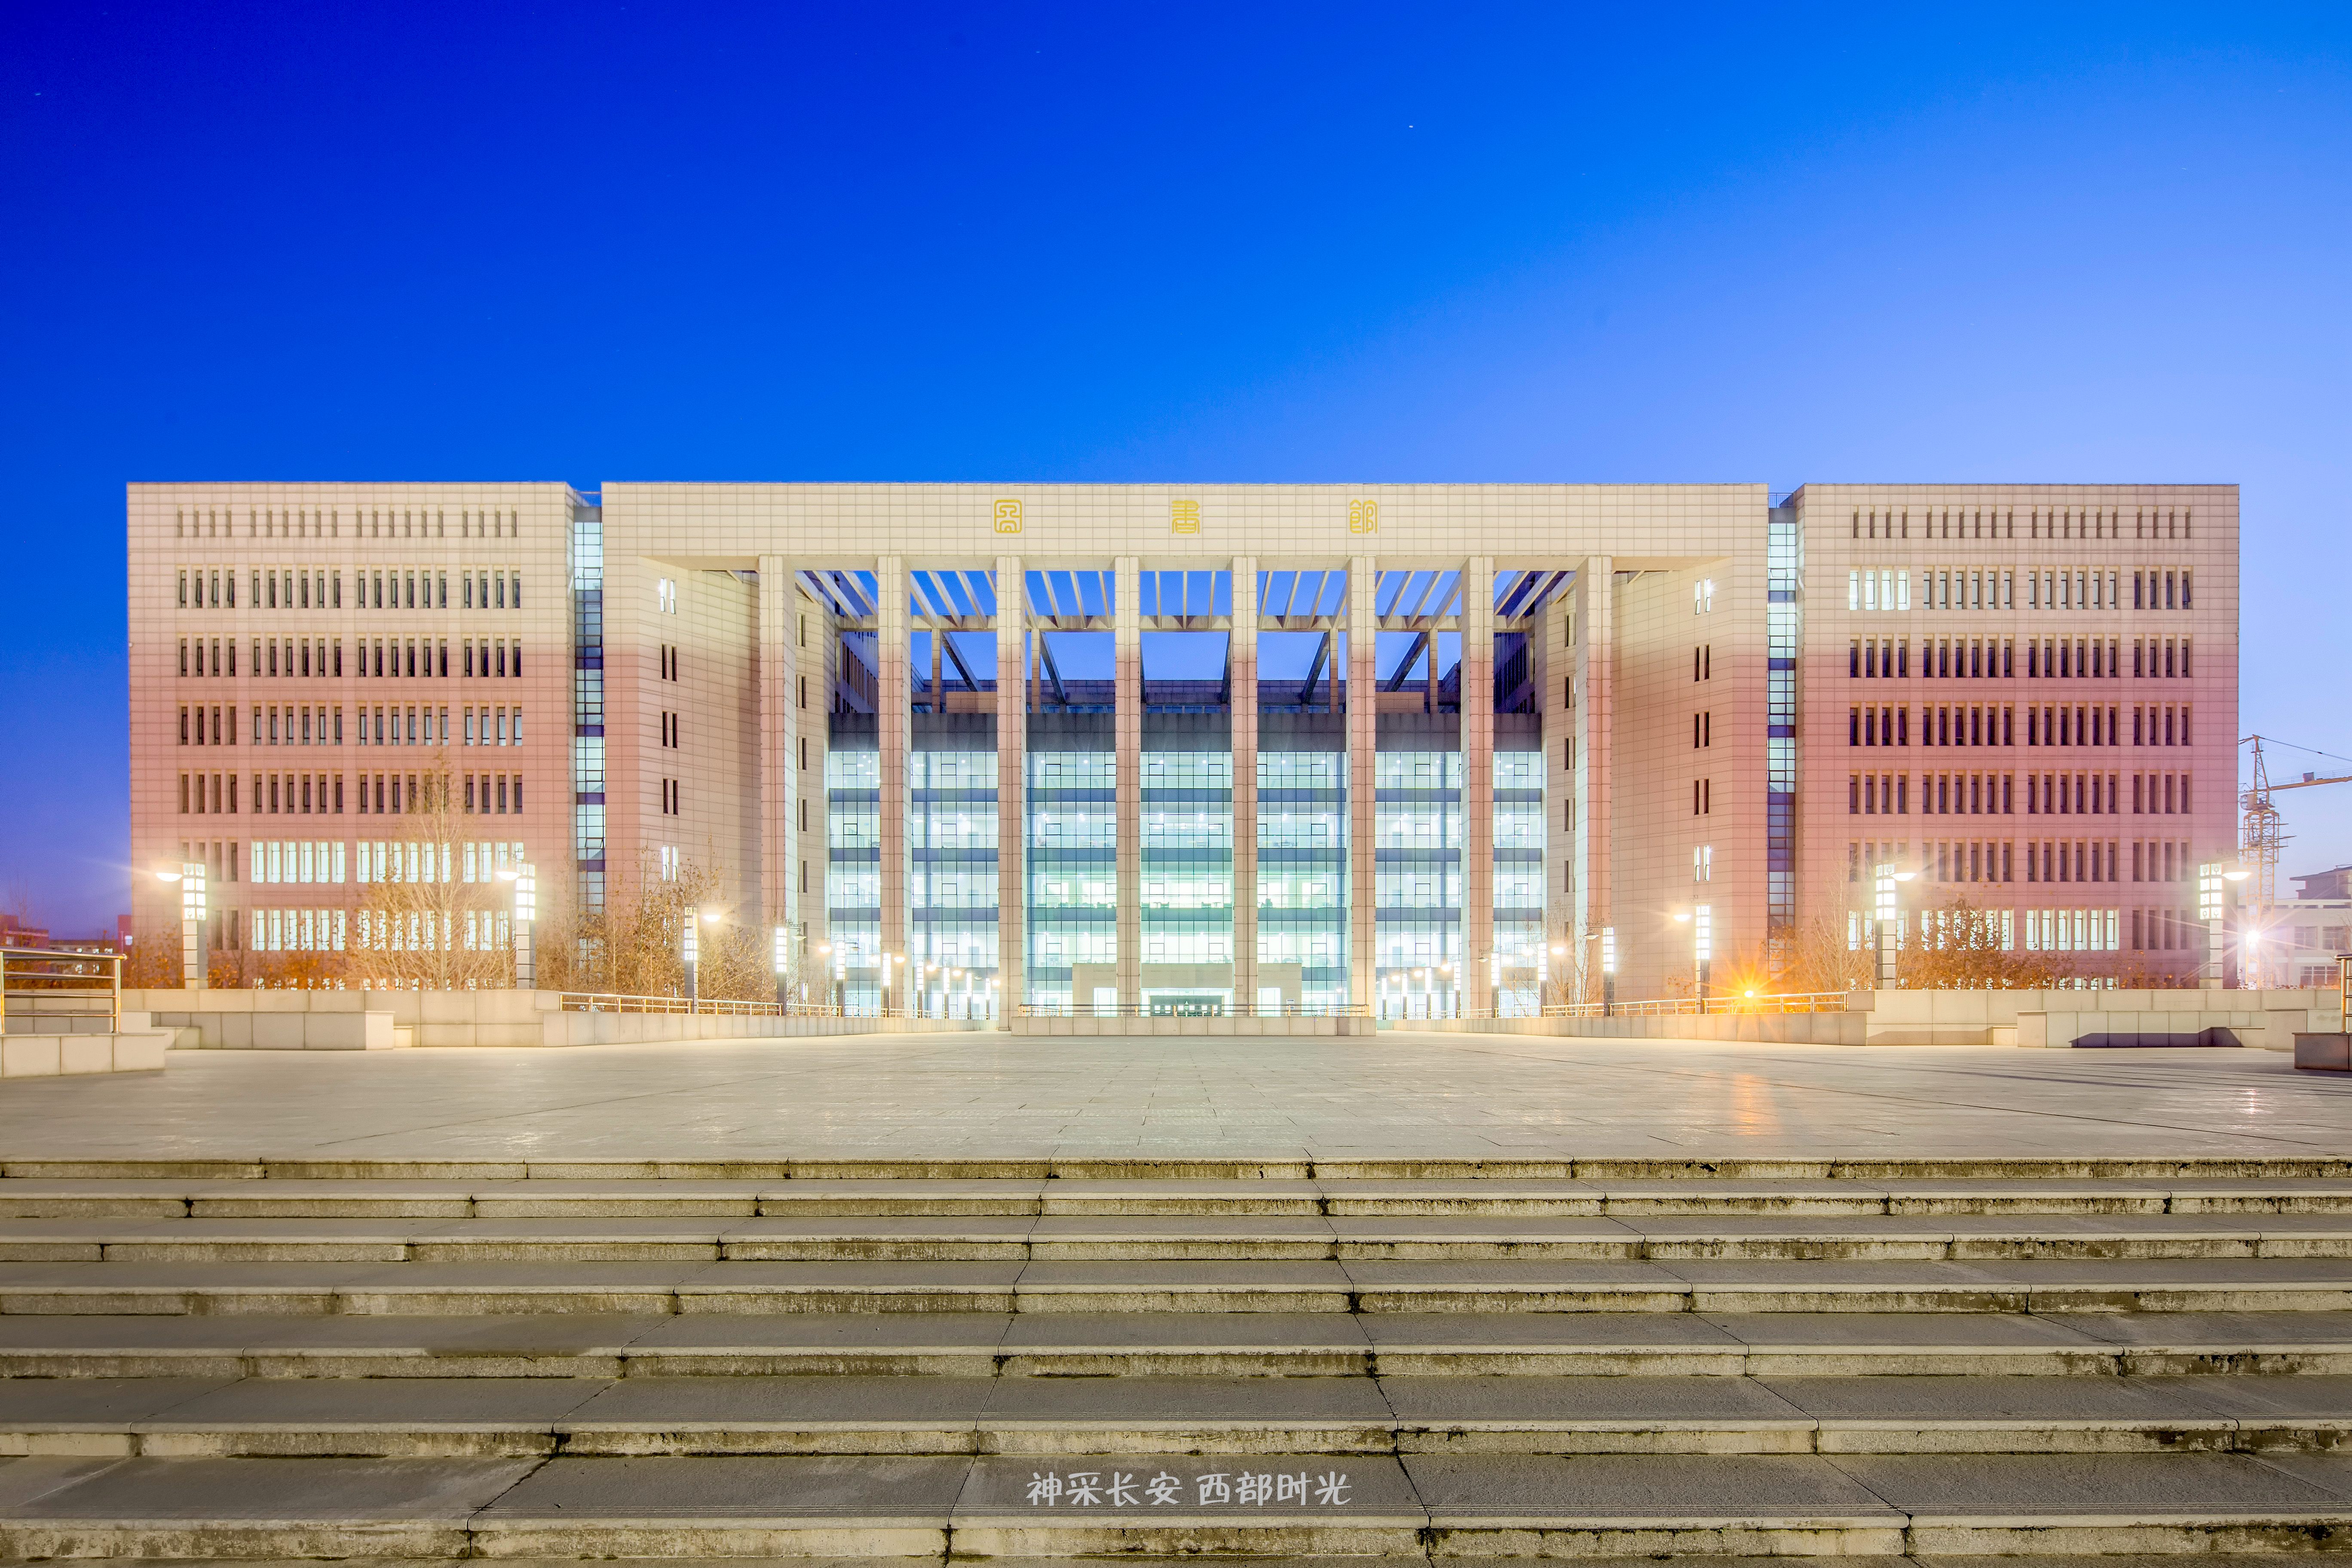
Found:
1371,752 -> 1463,1018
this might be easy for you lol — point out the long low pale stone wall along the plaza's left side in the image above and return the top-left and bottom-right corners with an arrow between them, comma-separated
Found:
125,990 -> 990,1051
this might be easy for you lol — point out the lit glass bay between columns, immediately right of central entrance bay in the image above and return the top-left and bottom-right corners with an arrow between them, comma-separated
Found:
1237,752 -> 1348,1011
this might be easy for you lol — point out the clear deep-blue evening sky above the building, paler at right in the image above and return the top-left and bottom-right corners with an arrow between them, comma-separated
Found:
0,0 -> 2352,928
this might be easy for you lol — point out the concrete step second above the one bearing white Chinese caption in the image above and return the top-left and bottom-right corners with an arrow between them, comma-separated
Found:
0,1312 -> 2352,1380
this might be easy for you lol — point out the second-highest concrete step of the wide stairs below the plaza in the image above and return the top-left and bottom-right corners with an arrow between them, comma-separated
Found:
14,1161 -> 2352,1220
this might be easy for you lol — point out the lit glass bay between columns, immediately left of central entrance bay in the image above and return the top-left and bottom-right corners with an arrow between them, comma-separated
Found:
1028,750 -> 1115,1008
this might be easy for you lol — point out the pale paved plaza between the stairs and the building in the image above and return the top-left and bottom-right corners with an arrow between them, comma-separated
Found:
0,1032 -> 2352,1159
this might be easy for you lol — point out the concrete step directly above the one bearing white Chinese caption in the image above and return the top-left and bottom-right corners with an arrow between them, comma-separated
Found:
0,1375 -> 2352,1458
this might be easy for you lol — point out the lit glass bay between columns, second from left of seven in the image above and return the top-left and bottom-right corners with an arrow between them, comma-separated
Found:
906,750 -> 1000,1018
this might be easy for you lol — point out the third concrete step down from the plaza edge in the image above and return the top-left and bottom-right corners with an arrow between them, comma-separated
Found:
14,1213 -> 2352,1262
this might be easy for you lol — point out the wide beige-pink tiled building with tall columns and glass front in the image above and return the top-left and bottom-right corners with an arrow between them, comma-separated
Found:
129,484 -> 2237,1008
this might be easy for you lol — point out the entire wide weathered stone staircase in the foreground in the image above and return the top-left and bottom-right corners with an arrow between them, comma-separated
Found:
0,1159 -> 2352,1568
